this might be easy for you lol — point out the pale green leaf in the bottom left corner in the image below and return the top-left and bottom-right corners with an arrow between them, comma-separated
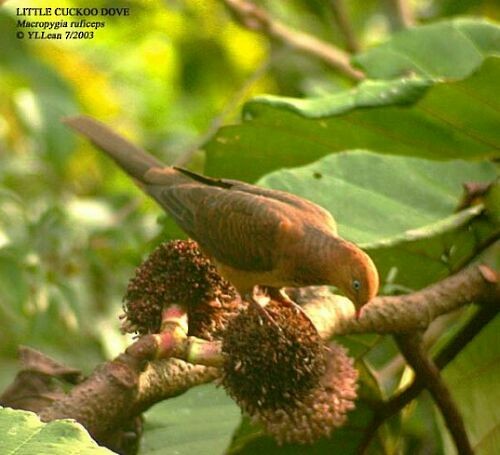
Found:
0,407 -> 114,455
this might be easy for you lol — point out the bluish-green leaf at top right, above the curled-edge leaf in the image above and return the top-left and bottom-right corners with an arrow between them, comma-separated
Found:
354,18 -> 500,79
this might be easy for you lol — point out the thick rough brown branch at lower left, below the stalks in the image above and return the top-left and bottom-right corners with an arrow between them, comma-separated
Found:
40,359 -> 217,444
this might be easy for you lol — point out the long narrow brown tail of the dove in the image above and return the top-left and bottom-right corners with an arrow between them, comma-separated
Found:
63,115 -> 165,184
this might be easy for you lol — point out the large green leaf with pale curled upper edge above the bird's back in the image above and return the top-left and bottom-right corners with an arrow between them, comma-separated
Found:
206,57 -> 500,181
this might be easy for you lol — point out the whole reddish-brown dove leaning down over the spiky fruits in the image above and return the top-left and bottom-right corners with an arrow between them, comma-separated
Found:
65,116 -> 379,312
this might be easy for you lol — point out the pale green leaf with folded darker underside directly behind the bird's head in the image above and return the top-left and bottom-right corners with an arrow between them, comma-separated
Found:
259,150 -> 499,288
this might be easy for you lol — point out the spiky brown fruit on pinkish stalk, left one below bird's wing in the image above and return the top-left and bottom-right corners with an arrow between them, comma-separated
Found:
122,240 -> 237,337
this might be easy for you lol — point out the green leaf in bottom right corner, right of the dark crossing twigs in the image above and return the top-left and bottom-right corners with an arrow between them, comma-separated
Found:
443,316 -> 500,455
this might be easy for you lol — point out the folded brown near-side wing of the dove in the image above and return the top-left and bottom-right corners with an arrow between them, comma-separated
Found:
149,183 -> 296,272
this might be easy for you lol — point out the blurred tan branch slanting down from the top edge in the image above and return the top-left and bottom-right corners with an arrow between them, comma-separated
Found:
222,0 -> 364,81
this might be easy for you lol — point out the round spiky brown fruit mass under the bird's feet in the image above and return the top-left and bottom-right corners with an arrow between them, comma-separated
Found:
221,301 -> 357,443
